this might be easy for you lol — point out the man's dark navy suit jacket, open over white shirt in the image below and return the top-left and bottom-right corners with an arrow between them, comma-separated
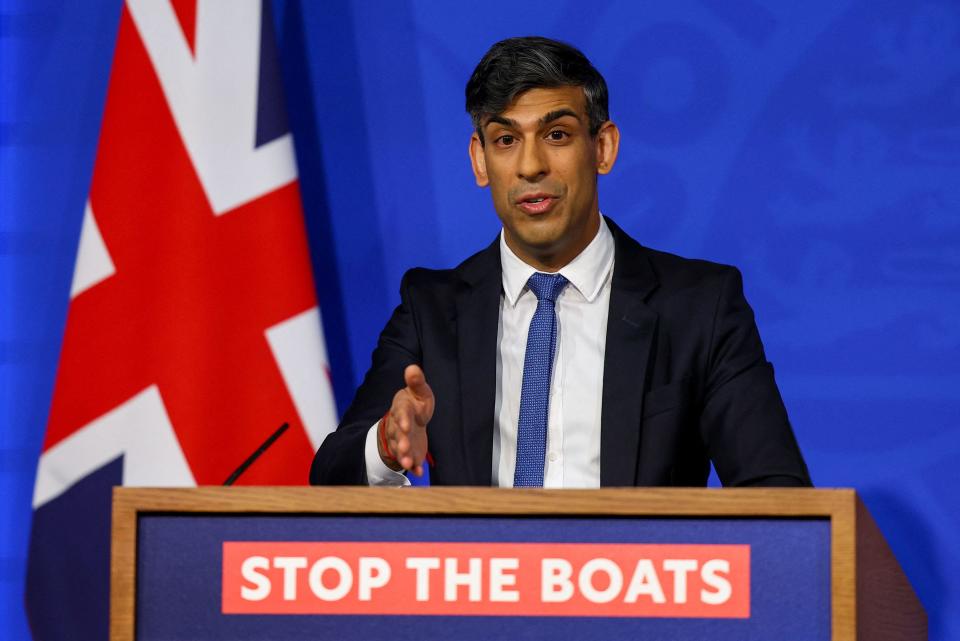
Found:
310,219 -> 810,486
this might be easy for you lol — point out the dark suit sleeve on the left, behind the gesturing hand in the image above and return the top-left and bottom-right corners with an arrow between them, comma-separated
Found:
310,271 -> 421,485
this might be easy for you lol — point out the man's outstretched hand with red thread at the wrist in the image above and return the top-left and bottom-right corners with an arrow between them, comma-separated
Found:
377,365 -> 434,476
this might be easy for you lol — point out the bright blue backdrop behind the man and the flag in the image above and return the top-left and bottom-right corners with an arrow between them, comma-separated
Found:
0,0 -> 960,639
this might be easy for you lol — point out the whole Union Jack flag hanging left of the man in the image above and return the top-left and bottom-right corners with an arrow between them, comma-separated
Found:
26,0 -> 336,641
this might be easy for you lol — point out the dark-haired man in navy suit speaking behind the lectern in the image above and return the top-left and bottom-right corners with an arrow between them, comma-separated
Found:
310,38 -> 810,487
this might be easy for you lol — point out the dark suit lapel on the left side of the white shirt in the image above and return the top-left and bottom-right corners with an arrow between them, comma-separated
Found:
456,239 -> 503,486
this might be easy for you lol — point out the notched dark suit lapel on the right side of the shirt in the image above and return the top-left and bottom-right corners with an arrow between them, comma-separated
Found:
600,219 -> 657,486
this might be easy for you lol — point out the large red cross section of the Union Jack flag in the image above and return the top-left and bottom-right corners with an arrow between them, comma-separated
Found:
44,9 -> 316,484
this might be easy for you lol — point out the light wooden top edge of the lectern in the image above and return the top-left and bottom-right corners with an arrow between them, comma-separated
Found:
114,486 -> 857,520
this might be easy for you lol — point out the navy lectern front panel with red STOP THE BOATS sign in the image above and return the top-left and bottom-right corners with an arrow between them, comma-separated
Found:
135,508 -> 831,641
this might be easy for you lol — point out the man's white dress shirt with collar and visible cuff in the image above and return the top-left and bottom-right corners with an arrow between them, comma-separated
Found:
365,217 -> 614,488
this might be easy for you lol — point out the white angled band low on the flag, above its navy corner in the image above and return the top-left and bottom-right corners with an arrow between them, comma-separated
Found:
33,385 -> 196,509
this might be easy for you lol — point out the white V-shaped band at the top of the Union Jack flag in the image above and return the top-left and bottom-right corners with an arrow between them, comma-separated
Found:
127,0 -> 297,215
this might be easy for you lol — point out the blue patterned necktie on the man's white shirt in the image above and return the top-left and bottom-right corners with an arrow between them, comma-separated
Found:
513,273 -> 567,487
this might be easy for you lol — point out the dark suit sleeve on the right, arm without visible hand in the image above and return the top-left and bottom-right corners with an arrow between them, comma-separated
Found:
701,268 -> 811,486
